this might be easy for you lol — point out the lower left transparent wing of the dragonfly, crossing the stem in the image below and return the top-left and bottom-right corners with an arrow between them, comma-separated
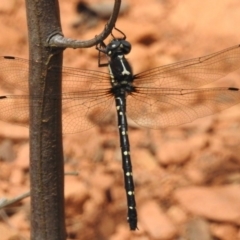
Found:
0,90 -> 114,134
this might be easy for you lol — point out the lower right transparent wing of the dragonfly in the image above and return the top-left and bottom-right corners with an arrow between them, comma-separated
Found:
127,88 -> 240,128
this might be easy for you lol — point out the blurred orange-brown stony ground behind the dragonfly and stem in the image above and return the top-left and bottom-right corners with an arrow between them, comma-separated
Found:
0,0 -> 240,240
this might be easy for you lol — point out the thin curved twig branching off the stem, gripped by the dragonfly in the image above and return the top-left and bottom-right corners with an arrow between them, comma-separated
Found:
47,0 -> 121,48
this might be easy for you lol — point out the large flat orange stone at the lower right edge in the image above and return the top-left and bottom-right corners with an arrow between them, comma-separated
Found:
175,185 -> 240,224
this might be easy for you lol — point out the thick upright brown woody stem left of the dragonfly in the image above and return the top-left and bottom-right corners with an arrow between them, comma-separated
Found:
26,0 -> 66,240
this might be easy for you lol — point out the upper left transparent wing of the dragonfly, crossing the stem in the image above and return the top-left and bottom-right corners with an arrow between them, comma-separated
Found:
0,56 -> 111,93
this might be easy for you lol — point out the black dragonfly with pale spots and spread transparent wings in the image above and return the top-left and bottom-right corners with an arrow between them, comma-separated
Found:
0,31 -> 240,230
